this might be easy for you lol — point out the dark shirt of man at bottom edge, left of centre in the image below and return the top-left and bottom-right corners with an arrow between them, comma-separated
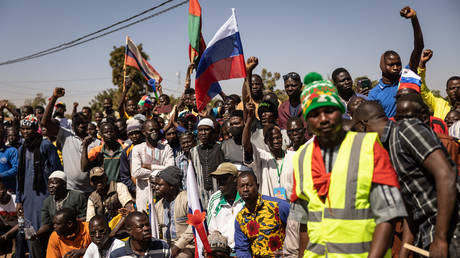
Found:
110,238 -> 171,258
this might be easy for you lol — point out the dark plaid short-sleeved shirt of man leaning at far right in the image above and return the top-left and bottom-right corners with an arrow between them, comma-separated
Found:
381,119 -> 460,248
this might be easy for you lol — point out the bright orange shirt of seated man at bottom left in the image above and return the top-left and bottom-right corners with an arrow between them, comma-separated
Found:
46,222 -> 91,258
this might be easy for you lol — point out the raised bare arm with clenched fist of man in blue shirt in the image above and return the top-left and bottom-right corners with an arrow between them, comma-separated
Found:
399,6 -> 424,72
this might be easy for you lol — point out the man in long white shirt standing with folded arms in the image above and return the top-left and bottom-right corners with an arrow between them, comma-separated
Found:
131,120 -> 174,211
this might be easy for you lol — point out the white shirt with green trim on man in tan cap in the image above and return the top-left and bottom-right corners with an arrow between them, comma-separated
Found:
206,190 -> 244,249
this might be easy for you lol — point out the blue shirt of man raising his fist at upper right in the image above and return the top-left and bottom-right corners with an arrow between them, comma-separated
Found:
368,79 -> 398,117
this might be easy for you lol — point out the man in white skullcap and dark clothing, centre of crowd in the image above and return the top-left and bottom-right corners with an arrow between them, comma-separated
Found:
190,117 -> 224,207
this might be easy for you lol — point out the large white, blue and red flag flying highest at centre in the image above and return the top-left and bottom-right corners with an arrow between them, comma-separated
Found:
195,9 -> 246,111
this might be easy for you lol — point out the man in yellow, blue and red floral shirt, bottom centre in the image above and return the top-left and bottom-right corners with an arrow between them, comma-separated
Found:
235,171 -> 289,258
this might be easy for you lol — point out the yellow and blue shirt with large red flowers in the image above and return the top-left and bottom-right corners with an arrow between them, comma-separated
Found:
235,194 -> 289,258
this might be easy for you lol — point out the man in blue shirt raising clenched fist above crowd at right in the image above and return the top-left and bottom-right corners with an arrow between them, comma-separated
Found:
368,6 -> 424,117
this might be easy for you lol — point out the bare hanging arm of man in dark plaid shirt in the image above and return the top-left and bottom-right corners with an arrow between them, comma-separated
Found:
423,149 -> 457,257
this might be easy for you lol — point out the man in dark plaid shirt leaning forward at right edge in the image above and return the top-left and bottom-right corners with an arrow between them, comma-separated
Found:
354,101 -> 460,257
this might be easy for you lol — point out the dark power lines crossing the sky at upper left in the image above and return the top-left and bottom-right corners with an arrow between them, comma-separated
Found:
0,0 -> 189,65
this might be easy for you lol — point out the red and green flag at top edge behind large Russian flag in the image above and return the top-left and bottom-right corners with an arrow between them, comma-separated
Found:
188,0 -> 206,67
